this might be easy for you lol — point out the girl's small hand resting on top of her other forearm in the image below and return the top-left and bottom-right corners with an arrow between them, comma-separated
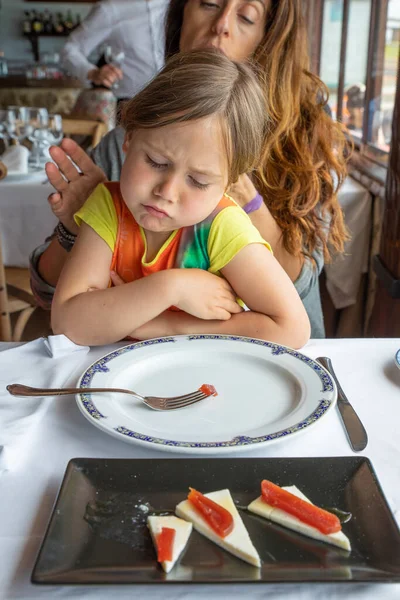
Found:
173,269 -> 243,321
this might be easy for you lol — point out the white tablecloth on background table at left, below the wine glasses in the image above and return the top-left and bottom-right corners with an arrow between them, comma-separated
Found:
0,171 -> 57,267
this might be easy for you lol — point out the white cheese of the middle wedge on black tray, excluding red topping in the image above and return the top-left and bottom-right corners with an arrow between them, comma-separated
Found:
175,490 -> 261,567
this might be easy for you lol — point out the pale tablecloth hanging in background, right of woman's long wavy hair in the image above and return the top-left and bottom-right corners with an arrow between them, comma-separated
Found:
325,177 -> 372,309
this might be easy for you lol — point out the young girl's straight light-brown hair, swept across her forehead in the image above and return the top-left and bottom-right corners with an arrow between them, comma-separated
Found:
121,50 -> 267,185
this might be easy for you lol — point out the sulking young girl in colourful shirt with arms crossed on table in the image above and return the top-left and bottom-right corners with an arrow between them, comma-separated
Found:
52,51 -> 310,347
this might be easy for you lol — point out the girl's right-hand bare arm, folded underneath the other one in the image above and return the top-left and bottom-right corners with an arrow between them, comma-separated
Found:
127,244 -> 310,348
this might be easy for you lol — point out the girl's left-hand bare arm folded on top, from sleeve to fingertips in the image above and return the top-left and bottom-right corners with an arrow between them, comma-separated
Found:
51,223 -> 241,345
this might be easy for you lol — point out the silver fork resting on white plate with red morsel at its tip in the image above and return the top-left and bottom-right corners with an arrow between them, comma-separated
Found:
7,383 -> 212,410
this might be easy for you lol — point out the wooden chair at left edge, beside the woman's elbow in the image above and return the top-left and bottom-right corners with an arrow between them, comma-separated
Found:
0,239 -> 36,342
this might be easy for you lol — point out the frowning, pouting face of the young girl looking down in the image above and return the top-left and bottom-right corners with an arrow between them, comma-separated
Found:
120,116 -> 228,234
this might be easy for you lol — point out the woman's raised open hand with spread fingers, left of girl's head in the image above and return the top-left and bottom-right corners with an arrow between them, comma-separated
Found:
46,138 -> 106,233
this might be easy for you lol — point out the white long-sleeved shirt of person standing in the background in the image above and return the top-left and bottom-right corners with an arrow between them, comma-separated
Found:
61,0 -> 168,98
